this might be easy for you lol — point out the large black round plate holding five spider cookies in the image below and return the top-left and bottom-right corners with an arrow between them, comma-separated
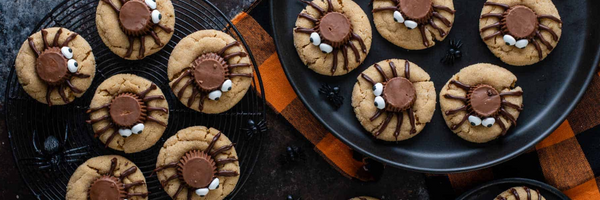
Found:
271,0 -> 600,173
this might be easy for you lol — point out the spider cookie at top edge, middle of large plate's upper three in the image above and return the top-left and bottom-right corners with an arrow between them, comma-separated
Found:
371,0 -> 456,50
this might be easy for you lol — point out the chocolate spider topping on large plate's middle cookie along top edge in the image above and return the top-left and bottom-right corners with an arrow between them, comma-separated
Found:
371,0 -> 456,47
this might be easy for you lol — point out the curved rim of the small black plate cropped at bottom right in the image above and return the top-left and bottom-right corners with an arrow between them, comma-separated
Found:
456,178 -> 571,200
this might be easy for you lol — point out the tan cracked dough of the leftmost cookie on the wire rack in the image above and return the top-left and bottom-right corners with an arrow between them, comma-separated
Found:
15,27 -> 96,105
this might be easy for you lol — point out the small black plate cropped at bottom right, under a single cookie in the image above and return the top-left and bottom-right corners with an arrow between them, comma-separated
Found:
456,178 -> 571,200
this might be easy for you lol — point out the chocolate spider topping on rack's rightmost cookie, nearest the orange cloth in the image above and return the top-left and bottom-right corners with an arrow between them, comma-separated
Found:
172,41 -> 252,111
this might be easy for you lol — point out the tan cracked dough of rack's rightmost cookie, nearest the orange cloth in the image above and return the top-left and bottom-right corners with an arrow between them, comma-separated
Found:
167,30 -> 253,114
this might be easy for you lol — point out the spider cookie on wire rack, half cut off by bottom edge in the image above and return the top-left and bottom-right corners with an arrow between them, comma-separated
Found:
65,155 -> 148,200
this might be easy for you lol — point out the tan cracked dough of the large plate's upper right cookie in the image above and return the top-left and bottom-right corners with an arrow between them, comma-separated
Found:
479,0 -> 562,66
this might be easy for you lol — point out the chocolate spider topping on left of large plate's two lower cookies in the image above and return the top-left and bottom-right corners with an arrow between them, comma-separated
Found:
361,60 -> 417,138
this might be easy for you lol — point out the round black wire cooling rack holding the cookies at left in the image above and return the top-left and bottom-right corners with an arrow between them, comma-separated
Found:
5,0 -> 266,199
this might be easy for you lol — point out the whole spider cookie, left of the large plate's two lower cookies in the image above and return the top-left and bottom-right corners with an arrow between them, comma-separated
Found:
352,59 -> 436,141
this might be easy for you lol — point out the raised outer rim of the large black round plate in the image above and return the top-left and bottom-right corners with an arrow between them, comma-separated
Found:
269,0 -> 600,174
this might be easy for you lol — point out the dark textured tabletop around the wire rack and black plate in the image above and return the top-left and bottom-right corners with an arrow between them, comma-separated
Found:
0,0 -> 428,200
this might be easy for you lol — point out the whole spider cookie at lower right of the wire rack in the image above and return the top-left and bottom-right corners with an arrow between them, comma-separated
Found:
154,126 -> 240,200
